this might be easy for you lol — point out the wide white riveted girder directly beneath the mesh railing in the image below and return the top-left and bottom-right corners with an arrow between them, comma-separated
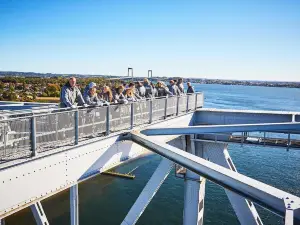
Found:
0,114 -> 192,218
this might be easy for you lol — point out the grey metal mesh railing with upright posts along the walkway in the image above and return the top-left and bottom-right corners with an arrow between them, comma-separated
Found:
0,93 -> 203,163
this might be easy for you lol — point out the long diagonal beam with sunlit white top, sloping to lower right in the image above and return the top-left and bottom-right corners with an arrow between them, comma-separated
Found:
131,132 -> 300,220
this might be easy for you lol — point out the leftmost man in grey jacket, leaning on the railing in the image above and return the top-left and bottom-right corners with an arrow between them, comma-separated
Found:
60,77 -> 87,108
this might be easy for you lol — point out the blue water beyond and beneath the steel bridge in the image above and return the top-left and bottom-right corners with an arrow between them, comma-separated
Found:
6,84 -> 300,225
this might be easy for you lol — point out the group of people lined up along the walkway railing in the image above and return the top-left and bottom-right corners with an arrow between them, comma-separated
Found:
60,77 -> 195,108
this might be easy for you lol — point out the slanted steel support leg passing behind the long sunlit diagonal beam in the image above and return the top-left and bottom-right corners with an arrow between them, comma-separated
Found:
202,142 -> 263,225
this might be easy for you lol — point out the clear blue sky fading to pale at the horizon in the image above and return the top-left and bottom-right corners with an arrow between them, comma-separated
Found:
0,0 -> 300,81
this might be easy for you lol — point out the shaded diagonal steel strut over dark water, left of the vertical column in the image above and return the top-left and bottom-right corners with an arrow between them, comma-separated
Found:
121,158 -> 174,225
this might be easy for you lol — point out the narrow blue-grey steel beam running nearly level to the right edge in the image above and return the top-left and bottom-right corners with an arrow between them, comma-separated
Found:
142,122 -> 300,135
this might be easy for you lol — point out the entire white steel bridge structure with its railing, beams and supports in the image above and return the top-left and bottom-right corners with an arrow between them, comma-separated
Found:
0,93 -> 300,225
